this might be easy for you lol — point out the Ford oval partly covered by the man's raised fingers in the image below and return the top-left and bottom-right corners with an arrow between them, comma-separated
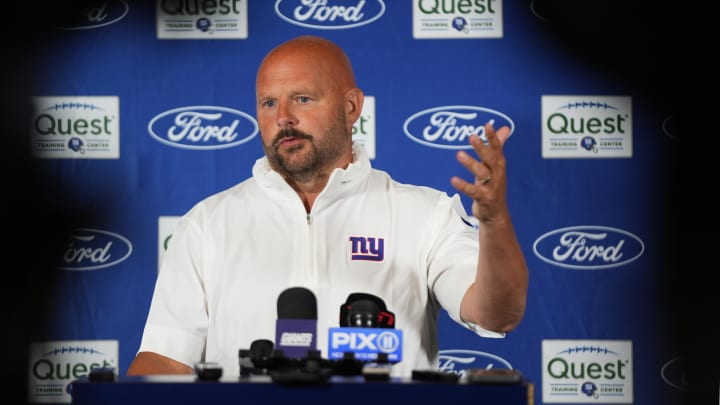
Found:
403,105 -> 515,149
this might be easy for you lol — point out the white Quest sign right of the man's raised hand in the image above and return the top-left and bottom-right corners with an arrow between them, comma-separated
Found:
542,96 -> 633,159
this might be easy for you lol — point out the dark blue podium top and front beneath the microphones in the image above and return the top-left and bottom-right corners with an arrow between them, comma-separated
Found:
69,375 -> 533,405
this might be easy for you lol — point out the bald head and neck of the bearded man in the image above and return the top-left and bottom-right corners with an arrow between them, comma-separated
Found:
255,36 -> 364,185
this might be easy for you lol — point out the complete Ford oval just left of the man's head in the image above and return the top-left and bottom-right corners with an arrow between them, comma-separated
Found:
148,106 -> 258,150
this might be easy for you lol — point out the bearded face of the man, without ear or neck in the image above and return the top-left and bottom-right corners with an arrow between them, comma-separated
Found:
256,54 -> 352,180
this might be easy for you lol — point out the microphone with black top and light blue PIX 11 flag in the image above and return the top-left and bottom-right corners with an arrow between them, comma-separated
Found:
328,293 -> 402,364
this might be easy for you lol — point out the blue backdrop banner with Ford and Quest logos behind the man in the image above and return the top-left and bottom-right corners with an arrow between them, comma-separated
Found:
16,0 -> 687,404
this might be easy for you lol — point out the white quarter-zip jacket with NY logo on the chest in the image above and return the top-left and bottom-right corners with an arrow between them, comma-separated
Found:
139,144 -> 504,377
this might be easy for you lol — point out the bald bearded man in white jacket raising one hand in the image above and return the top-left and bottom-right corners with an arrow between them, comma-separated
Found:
128,36 -> 528,376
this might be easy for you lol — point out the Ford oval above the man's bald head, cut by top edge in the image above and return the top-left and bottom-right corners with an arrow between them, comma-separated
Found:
275,0 -> 385,30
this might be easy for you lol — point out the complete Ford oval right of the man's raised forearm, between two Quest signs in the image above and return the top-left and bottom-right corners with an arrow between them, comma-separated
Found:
533,226 -> 645,270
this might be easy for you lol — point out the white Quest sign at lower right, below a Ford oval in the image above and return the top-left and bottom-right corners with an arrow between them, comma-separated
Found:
542,340 -> 633,404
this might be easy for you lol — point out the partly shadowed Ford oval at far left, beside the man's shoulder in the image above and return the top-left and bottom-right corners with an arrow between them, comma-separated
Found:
58,229 -> 132,270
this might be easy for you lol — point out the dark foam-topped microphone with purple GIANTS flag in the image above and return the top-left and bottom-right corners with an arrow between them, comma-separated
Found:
275,287 -> 317,358
